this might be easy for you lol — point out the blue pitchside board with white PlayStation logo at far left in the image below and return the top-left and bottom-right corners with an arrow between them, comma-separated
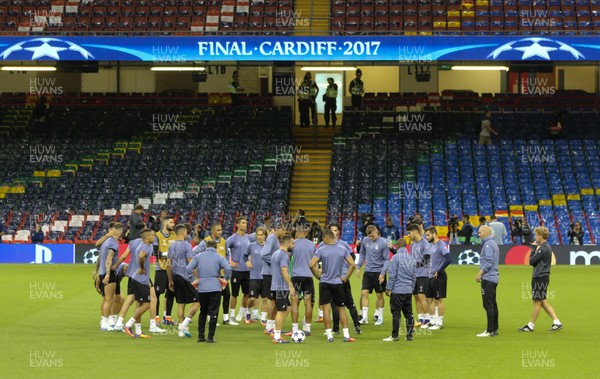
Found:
0,244 -> 75,264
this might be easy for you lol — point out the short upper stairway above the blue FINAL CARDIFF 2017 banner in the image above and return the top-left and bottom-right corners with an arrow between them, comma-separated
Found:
294,0 -> 330,36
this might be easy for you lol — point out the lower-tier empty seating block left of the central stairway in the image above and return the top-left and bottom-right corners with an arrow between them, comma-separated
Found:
0,94 -> 293,242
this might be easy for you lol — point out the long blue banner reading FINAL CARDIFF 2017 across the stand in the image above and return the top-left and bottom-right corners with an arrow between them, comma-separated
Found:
0,35 -> 600,64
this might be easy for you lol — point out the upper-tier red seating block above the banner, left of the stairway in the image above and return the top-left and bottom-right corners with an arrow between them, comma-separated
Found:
0,0 -> 294,35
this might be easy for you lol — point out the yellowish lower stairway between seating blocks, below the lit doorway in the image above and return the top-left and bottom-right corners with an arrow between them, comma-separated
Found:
289,128 -> 339,224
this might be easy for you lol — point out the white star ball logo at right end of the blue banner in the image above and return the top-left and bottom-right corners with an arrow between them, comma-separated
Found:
487,37 -> 585,60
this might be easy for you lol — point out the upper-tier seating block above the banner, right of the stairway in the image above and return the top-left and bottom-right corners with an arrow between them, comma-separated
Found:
330,0 -> 600,35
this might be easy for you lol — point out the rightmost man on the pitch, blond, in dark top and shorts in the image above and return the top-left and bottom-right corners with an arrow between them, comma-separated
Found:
519,226 -> 562,332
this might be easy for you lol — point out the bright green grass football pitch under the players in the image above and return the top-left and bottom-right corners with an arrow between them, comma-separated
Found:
0,265 -> 600,378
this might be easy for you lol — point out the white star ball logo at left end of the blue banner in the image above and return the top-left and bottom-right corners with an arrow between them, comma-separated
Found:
0,38 -> 94,61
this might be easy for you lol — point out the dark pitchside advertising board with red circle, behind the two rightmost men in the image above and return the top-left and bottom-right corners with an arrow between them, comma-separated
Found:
450,245 -> 600,266
